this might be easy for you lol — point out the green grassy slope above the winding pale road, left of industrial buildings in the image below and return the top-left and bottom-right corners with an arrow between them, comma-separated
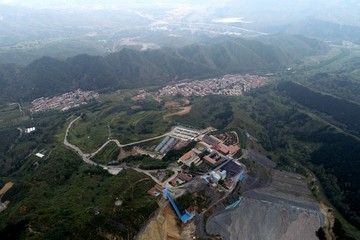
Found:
69,91 -> 170,152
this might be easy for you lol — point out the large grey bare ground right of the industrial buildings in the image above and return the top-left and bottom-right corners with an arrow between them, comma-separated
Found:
206,170 -> 324,240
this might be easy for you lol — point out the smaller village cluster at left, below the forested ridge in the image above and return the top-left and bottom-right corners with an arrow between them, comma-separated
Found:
30,89 -> 99,113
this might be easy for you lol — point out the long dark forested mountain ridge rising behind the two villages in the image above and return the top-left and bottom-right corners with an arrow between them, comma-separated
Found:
0,35 -> 327,101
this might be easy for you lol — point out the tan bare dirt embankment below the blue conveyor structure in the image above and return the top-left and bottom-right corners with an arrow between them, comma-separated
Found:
137,204 -> 180,240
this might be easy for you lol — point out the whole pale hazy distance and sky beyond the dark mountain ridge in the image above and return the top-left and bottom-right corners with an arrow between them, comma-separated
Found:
0,0 -> 360,65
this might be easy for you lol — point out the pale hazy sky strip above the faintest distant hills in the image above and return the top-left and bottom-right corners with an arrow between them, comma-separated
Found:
0,0 -> 360,25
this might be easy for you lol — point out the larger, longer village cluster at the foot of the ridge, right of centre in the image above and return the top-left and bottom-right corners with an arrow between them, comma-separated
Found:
158,74 -> 267,97
